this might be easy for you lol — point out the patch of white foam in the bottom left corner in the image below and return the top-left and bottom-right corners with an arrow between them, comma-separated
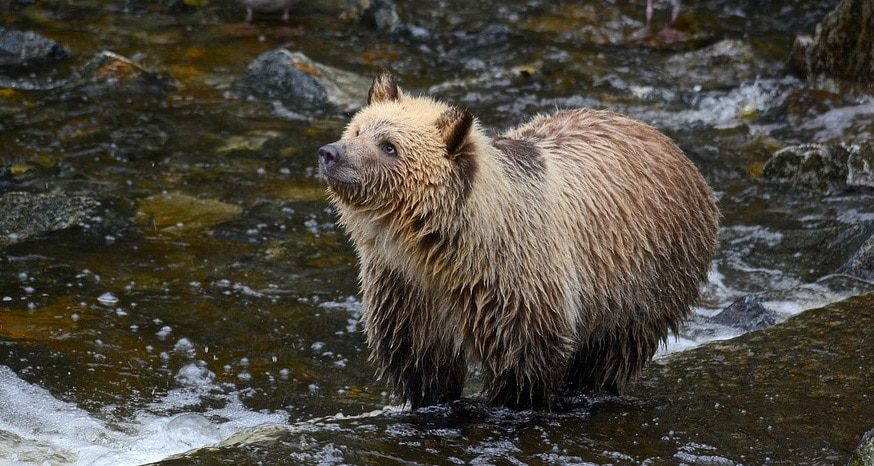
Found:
0,365 -> 288,466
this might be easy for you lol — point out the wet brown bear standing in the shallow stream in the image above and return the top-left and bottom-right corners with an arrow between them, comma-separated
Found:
319,73 -> 718,409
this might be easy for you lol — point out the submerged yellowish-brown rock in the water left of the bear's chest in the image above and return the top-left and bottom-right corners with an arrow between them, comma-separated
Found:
136,193 -> 243,234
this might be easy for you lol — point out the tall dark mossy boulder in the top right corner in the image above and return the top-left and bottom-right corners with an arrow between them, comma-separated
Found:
793,0 -> 874,90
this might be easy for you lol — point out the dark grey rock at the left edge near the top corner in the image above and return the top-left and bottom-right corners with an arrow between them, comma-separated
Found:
0,26 -> 69,69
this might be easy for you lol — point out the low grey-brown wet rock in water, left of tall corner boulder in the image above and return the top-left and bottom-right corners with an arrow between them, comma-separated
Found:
665,39 -> 775,89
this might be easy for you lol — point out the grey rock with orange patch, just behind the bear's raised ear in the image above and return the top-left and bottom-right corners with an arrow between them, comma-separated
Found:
237,49 -> 370,115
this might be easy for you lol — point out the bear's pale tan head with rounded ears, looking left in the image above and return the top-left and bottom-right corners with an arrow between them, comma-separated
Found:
319,72 -> 476,215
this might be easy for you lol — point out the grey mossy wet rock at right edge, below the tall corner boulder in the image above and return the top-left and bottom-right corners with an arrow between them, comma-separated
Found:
763,142 -> 874,193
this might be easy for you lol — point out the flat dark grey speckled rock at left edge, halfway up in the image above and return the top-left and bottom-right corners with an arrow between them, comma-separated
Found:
0,192 -> 100,247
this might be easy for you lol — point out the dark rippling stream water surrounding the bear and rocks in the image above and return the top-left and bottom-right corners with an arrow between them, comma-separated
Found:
0,0 -> 874,465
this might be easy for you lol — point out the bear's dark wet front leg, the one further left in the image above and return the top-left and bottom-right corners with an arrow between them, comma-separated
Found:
362,267 -> 467,409
